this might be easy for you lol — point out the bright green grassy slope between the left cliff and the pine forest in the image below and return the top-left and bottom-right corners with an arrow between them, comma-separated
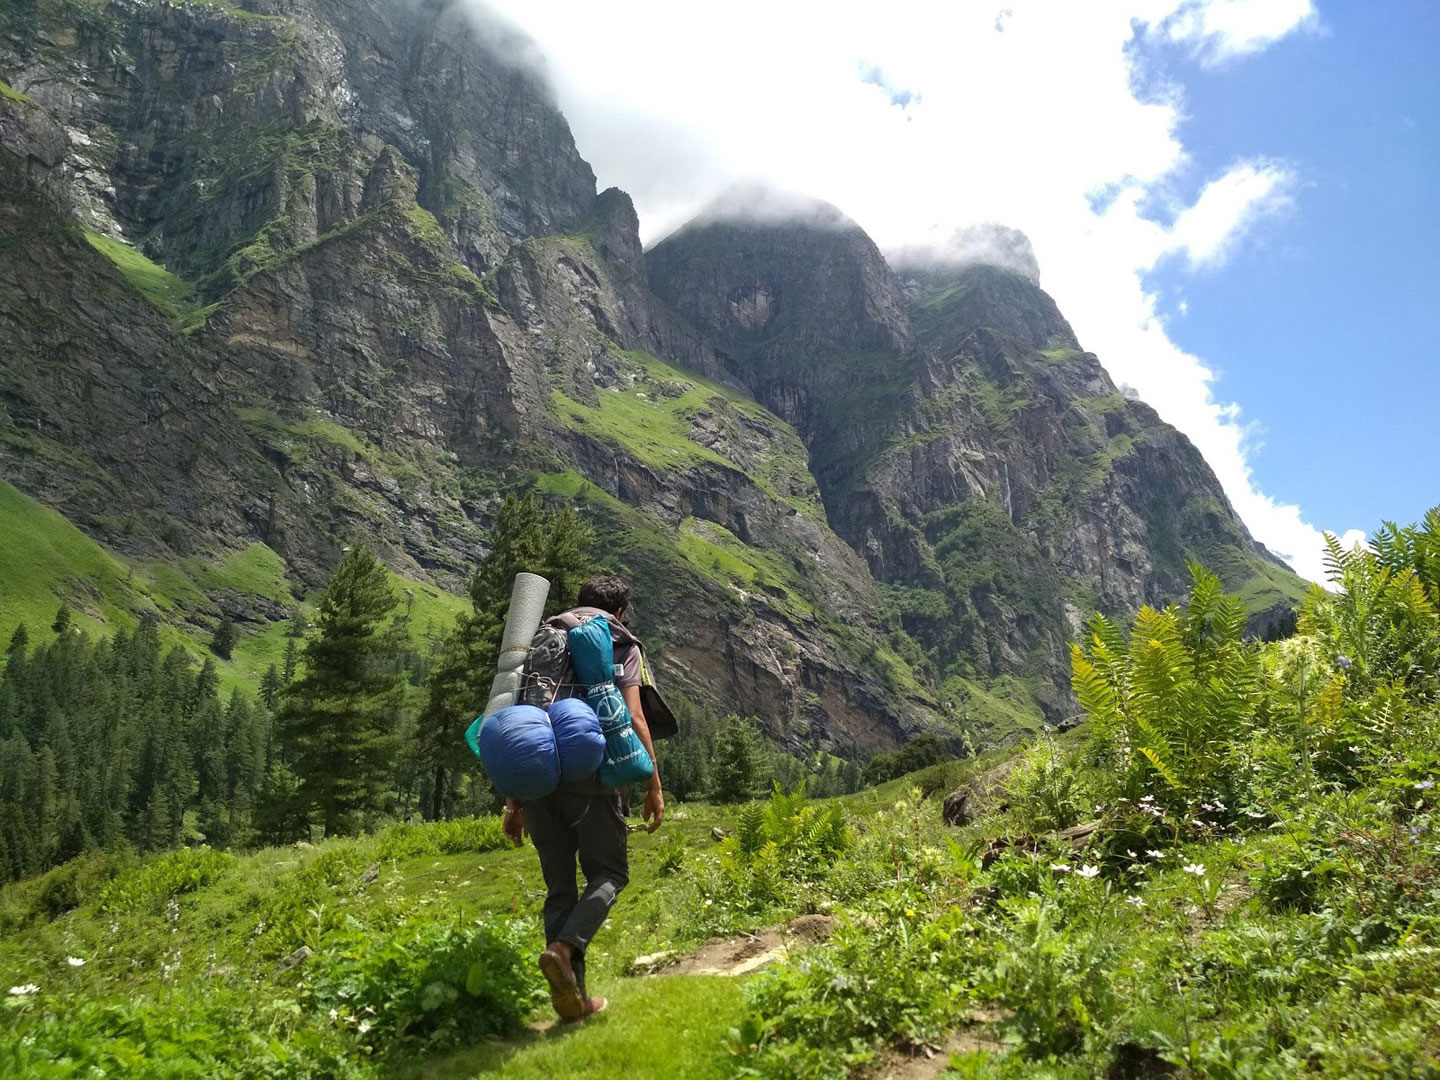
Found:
0,481 -> 468,691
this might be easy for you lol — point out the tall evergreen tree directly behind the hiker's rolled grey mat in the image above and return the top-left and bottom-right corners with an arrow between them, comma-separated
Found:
418,495 -> 595,818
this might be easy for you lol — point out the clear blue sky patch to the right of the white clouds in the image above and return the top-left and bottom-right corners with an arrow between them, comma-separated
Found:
1148,0 -> 1440,528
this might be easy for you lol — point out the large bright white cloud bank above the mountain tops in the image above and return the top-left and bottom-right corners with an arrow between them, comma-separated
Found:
472,0 -> 1347,577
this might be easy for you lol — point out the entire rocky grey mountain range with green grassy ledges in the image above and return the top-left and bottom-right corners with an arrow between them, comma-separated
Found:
0,0 -> 1296,753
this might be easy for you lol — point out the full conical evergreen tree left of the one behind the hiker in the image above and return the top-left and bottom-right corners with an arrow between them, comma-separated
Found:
278,546 -> 408,837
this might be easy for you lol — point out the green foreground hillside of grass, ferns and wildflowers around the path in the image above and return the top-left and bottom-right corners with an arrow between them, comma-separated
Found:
0,511 -> 1440,1079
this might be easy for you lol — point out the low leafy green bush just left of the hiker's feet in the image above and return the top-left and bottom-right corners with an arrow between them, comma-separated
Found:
308,920 -> 546,1050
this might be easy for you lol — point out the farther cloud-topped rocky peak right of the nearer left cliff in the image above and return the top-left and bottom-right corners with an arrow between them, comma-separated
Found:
648,219 -> 1295,719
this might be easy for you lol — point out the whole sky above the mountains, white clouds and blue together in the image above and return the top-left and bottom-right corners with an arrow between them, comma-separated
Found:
486,0 -> 1416,580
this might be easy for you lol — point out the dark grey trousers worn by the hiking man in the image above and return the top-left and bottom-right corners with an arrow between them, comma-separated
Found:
524,791 -> 629,995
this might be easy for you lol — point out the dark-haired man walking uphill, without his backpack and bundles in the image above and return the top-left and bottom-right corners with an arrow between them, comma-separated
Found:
504,575 -> 665,1021
